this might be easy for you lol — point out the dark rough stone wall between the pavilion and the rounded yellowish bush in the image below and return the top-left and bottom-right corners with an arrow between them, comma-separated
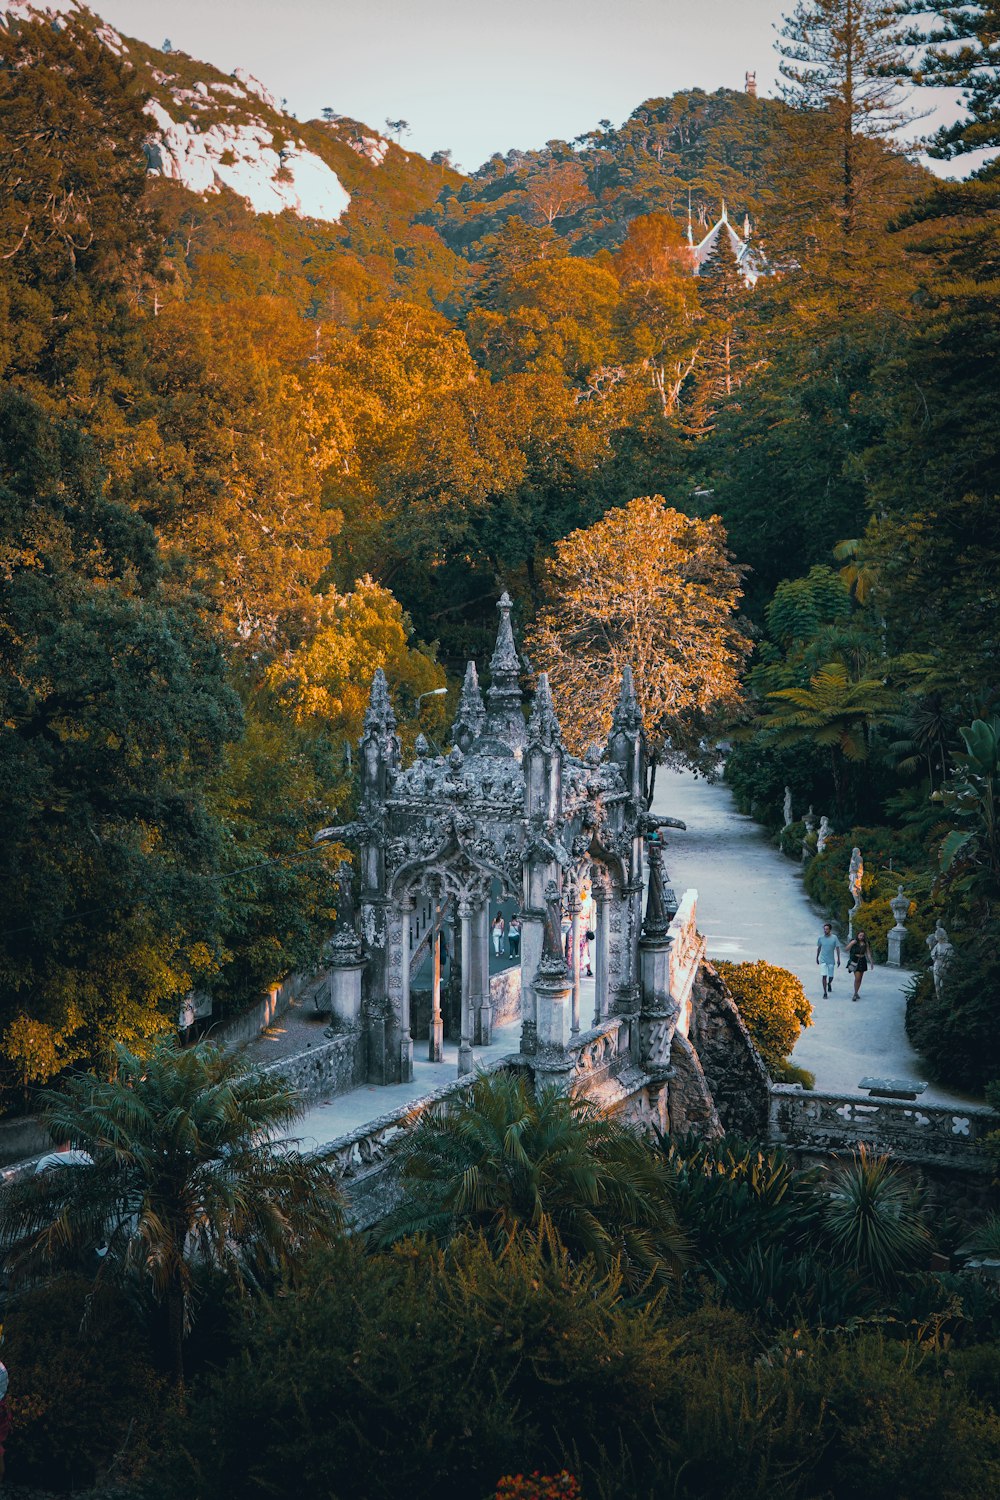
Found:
690,960 -> 772,1140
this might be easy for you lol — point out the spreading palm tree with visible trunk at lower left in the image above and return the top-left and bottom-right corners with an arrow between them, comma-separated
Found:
0,1041 -> 342,1383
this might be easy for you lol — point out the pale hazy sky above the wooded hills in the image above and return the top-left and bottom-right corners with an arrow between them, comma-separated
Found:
88,0 -> 793,171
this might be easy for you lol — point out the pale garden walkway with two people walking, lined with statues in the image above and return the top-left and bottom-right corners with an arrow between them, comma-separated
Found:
654,770 -> 970,1104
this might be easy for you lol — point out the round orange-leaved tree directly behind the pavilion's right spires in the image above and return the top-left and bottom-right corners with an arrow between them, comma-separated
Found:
528,495 -> 750,765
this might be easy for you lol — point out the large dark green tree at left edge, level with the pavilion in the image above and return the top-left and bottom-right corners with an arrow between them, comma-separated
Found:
0,390 -> 241,1085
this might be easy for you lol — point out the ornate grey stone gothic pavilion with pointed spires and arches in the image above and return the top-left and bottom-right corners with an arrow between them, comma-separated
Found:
328,594 -> 704,1104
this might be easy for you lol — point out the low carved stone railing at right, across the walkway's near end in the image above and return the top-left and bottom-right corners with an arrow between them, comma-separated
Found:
768,1083 -> 1000,1172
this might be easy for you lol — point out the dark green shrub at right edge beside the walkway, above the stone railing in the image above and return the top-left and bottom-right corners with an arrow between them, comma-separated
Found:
906,923 -> 1000,1092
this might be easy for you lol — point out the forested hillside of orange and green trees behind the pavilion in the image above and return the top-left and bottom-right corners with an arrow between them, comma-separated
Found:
0,6 -> 1000,1103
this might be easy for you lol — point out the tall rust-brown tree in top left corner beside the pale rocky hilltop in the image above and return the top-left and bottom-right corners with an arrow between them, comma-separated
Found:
0,15 -> 159,431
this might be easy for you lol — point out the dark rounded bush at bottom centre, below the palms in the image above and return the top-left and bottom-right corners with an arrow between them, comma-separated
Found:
153,1227 -> 678,1500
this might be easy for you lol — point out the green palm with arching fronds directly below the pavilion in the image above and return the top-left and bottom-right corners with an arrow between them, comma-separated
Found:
384,1073 -> 685,1287
